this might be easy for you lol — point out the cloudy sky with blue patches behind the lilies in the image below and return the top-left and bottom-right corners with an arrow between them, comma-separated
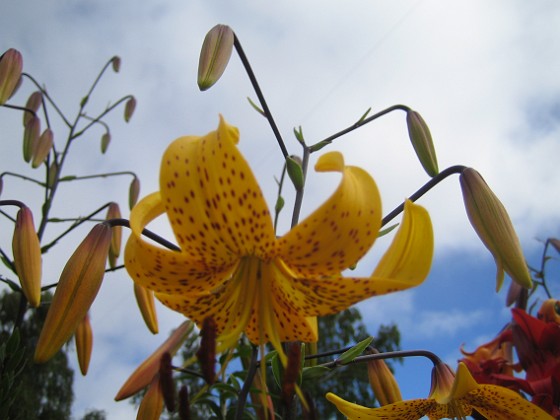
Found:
0,0 -> 560,419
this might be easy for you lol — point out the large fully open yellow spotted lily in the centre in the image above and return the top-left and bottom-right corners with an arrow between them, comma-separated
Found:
125,118 -> 433,364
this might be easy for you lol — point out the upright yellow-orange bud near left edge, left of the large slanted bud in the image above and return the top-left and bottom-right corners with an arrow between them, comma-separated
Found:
12,207 -> 42,308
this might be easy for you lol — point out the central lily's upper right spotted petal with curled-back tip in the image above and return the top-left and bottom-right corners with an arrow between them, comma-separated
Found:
279,152 -> 381,278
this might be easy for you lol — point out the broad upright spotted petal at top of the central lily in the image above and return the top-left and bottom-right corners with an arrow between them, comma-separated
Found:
160,117 -> 275,267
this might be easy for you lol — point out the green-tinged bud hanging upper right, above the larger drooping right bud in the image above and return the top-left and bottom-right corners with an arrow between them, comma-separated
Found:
406,110 -> 439,177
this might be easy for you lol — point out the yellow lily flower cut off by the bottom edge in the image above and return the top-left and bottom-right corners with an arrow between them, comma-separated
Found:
326,363 -> 553,420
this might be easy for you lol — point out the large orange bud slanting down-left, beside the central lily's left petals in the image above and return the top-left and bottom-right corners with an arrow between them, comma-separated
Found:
35,223 -> 111,363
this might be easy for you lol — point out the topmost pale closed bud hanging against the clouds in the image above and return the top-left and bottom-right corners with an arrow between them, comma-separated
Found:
198,25 -> 235,91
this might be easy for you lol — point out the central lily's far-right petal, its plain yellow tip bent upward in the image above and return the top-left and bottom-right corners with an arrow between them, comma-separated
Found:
274,201 -> 433,316
